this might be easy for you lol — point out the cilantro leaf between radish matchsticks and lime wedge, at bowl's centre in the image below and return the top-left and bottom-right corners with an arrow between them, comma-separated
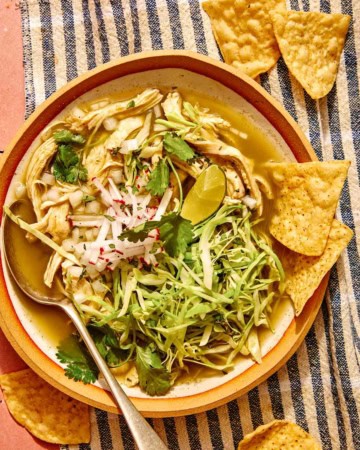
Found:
119,213 -> 193,257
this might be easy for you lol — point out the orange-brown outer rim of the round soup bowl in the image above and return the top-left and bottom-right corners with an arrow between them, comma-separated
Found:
0,51 -> 328,417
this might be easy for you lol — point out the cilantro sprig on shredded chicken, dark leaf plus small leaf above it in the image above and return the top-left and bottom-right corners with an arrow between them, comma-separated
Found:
53,130 -> 88,184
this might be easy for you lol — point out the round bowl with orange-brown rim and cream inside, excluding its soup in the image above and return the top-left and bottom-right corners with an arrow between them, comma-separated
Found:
0,51 -> 328,417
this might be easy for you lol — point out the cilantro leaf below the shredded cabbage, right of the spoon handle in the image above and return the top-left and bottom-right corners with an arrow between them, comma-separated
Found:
135,344 -> 171,395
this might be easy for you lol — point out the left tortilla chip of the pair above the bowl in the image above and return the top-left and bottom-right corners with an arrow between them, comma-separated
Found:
202,0 -> 286,78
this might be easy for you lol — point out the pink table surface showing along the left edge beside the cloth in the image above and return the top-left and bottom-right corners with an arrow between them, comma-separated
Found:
0,0 -> 59,450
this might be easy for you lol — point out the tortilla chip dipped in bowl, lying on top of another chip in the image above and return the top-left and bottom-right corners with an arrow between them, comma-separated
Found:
268,161 -> 350,256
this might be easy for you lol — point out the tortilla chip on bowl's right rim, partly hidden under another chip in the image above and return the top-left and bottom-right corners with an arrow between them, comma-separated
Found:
281,219 -> 353,316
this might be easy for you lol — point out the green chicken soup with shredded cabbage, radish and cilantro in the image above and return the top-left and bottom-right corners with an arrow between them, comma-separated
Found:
9,88 -> 290,395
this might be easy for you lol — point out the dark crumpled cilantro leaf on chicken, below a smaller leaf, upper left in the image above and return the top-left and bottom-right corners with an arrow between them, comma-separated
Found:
53,144 -> 88,184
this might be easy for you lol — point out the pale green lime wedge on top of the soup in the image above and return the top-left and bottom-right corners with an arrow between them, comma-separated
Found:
180,164 -> 226,225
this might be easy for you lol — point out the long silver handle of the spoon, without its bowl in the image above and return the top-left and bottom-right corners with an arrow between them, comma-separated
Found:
61,303 -> 167,450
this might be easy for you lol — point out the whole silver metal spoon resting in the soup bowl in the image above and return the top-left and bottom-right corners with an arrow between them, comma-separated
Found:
2,200 -> 167,450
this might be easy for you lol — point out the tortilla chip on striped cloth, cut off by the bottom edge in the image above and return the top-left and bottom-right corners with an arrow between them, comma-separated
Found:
238,420 -> 321,450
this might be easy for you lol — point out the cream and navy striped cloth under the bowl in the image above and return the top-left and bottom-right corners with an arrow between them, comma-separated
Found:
20,0 -> 360,450
